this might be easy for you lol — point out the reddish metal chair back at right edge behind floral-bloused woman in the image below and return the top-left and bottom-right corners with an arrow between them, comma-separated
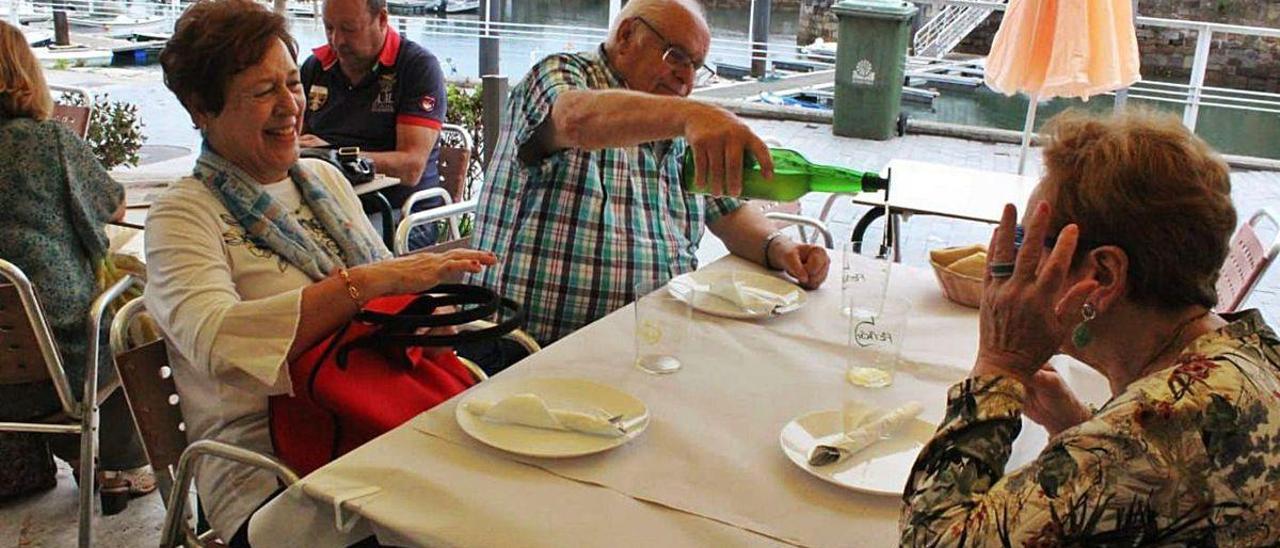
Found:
1216,207 -> 1280,312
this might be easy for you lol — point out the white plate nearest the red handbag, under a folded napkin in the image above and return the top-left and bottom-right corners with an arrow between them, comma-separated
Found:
454,378 -> 649,458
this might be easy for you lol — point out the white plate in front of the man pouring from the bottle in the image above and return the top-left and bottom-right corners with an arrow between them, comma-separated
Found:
667,270 -> 809,320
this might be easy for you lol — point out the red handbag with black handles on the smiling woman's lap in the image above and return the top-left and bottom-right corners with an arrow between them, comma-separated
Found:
268,284 -> 524,475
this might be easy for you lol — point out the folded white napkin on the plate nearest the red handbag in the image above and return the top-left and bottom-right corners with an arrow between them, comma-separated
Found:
462,393 -> 626,438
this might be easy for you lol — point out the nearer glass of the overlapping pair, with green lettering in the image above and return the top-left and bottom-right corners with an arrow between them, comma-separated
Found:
846,297 -> 911,388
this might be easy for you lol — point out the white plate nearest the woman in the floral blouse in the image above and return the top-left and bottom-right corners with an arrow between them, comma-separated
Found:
781,402 -> 934,497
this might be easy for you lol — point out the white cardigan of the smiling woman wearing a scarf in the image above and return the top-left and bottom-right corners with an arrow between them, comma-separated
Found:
145,160 -> 381,539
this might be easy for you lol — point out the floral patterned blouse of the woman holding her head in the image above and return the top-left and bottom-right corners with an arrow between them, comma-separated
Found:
901,311 -> 1280,547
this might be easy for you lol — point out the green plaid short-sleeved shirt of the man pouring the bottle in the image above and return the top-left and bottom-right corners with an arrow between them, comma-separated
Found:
471,47 -> 740,343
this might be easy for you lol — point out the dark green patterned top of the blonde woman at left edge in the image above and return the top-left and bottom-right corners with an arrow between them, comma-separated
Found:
0,118 -> 124,401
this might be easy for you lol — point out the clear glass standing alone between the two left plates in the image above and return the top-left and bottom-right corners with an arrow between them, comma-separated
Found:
635,280 -> 692,375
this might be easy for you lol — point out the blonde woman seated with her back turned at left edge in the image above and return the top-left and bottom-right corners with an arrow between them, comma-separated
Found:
0,22 -> 155,494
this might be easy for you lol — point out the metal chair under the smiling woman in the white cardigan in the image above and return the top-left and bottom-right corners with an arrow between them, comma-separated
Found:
111,298 -> 298,548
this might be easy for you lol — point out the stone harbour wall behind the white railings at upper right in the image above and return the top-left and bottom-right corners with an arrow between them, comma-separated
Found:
796,0 -> 1280,92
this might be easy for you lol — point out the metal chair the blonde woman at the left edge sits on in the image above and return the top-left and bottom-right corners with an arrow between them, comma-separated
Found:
0,259 -> 141,547
